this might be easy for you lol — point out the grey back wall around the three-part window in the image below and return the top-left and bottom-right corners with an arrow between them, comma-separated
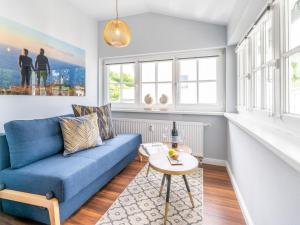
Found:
99,13 -> 236,159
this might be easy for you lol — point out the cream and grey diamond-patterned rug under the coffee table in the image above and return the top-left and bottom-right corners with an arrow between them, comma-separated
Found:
96,163 -> 203,225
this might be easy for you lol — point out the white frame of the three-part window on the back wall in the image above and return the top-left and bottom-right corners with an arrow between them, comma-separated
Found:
100,49 -> 225,112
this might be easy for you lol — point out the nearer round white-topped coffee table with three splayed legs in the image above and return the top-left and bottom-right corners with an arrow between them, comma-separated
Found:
149,152 -> 199,224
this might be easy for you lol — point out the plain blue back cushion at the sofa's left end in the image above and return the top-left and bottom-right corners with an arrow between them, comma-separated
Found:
4,117 -> 64,169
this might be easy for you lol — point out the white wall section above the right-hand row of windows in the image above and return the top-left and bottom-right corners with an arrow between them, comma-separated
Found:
227,0 -> 268,45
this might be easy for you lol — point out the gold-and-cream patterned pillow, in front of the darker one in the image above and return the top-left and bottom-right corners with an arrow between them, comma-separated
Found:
60,113 -> 102,155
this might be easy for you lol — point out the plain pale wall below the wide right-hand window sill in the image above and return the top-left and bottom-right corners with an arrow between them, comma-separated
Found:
228,122 -> 300,225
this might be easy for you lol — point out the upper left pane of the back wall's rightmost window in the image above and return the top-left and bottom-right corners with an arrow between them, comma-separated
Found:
179,59 -> 197,81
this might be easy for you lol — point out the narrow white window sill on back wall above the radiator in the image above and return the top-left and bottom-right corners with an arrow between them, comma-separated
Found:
112,108 -> 224,116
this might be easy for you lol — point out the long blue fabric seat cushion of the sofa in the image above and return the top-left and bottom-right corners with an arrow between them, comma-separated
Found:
0,135 -> 141,202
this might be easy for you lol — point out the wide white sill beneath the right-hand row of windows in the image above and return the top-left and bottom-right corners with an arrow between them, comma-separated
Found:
224,113 -> 300,172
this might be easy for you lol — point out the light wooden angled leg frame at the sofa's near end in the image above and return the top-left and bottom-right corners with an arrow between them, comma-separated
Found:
0,189 -> 60,225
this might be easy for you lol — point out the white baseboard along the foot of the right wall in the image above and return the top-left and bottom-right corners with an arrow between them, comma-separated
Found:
225,161 -> 254,225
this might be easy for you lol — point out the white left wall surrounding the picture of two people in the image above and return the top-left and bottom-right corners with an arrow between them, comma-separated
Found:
0,0 -> 98,132
